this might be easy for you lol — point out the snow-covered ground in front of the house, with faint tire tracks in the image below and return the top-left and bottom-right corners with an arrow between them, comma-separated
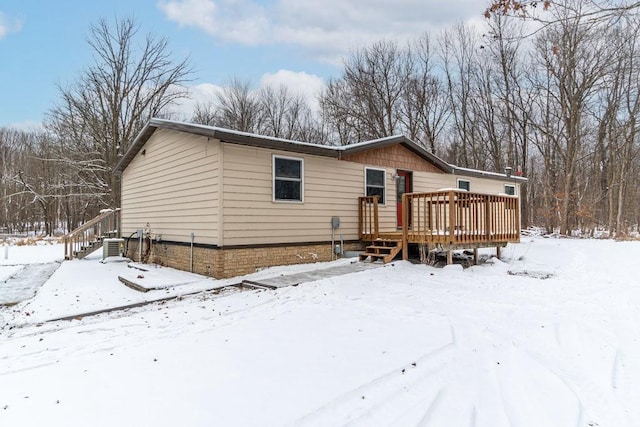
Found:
0,237 -> 640,427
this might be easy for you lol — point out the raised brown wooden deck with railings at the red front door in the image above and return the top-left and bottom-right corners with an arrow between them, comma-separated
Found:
358,190 -> 520,259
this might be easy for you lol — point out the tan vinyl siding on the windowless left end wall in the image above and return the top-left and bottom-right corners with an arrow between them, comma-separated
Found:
122,130 -> 220,244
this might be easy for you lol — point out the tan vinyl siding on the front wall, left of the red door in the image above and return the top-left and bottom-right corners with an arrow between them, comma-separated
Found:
223,144 -> 395,246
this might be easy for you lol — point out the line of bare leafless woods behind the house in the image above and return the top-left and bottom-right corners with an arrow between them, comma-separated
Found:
0,0 -> 640,235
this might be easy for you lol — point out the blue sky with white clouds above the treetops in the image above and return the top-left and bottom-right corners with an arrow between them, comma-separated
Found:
0,0 -> 485,129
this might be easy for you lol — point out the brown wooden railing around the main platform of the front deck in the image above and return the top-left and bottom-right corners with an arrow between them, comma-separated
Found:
402,190 -> 520,245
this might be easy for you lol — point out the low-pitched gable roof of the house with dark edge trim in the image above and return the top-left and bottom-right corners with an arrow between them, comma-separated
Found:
114,118 -> 526,181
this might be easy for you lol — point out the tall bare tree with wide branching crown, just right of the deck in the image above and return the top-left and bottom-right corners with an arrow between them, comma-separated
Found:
524,0 -> 612,233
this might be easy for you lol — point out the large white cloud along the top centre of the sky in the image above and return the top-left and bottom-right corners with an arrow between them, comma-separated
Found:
158,0 -> 483,63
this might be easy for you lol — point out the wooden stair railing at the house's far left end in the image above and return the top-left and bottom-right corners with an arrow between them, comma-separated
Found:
64,209 -> 120,260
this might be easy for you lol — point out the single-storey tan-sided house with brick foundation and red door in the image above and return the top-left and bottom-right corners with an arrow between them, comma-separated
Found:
115,119 -> 525,278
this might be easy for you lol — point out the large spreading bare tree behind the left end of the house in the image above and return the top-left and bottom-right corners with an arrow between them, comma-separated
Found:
49,19 -> 191,207
